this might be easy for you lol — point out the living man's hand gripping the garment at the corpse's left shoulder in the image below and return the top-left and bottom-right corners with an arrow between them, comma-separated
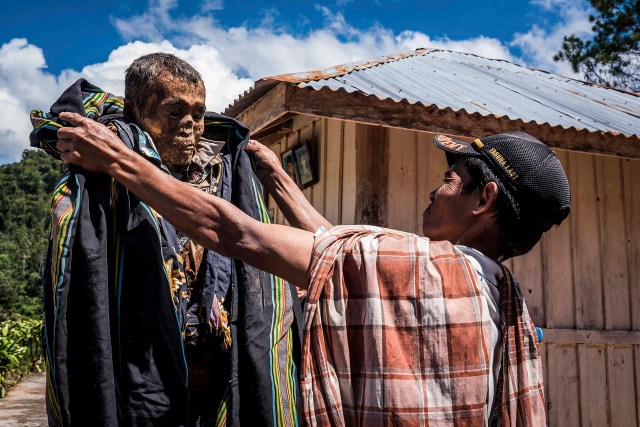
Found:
57,112 -> 124,173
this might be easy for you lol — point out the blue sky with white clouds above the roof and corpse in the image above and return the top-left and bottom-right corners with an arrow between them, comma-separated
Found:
0,0 -> 590,163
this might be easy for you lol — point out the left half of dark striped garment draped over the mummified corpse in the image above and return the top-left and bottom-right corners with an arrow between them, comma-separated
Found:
31,81 -> 188,426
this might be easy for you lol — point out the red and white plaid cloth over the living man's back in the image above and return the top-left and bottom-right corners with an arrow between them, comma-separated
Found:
301,226 -> 545,426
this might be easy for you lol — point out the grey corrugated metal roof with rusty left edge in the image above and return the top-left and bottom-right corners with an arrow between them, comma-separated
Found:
227,49 -> 640,136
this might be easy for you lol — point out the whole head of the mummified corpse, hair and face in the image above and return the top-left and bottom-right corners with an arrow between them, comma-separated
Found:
124,53 -> 206,169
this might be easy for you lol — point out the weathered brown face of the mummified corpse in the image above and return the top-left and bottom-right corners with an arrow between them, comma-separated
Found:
138,73 -> 205,167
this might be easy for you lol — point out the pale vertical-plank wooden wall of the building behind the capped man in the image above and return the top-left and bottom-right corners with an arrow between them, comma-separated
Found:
262,116 -> 640,427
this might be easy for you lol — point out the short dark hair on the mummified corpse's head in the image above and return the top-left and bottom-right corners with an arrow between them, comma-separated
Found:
124,53 -> 204,121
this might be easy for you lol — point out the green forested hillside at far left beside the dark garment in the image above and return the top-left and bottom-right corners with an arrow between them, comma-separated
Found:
0,150 -> 66,319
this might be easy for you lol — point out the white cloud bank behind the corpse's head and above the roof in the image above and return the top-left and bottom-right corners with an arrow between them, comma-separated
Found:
0,0 -> 589,163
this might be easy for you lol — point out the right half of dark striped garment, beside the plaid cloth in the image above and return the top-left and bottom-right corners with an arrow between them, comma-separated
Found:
178,112 -> 301,426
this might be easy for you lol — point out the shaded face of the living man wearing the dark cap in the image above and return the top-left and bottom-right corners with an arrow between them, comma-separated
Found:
422,160 -> 479,244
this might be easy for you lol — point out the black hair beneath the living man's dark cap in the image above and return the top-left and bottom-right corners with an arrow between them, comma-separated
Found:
462,157 -> 545,260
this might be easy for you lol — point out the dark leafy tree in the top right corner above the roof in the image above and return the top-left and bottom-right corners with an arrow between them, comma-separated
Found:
553,0 -> 640,92
